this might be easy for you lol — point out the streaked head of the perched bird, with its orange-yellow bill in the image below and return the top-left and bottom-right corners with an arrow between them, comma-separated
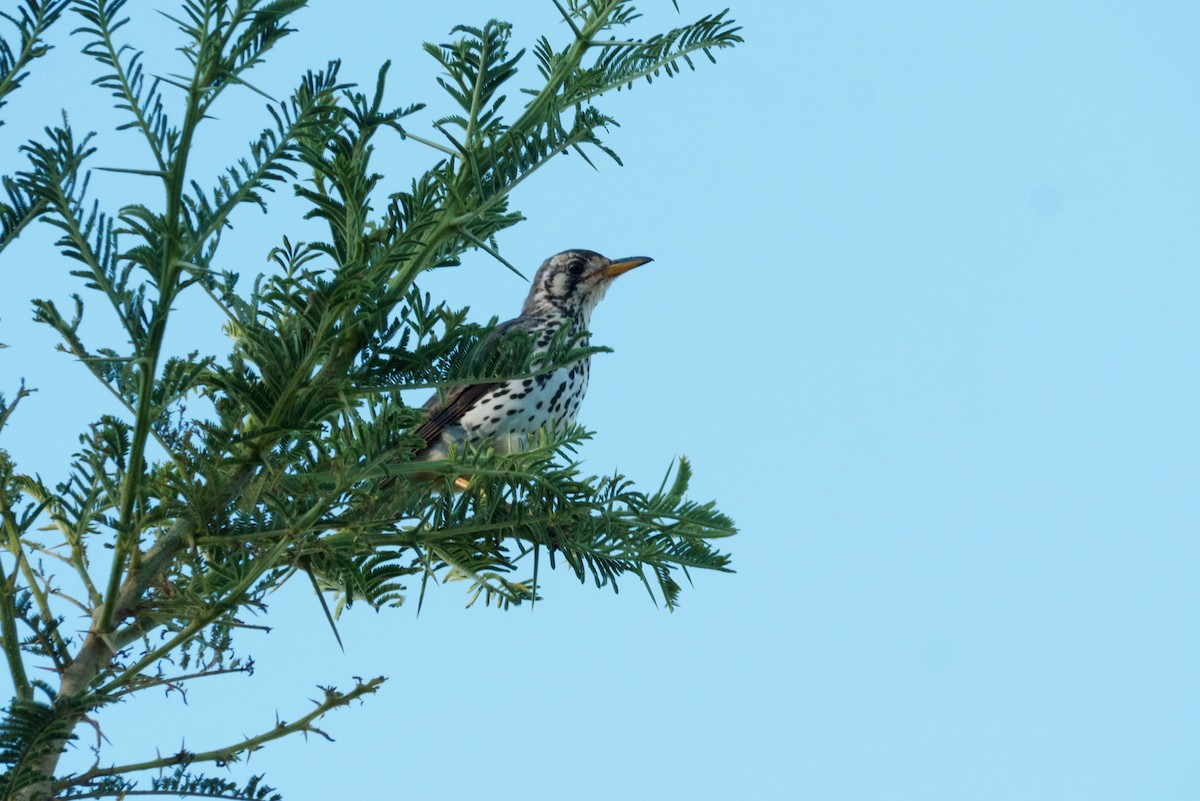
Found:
523,251 -> 650,324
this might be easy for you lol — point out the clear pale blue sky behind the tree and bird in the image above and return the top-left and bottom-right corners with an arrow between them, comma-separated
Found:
0,0 -> 1200,801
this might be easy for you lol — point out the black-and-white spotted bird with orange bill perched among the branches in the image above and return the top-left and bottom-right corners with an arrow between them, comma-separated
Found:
413,249 -> 652,465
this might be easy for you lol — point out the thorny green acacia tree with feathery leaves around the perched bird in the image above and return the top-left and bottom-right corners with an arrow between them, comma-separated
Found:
0,0 -> 740,800
